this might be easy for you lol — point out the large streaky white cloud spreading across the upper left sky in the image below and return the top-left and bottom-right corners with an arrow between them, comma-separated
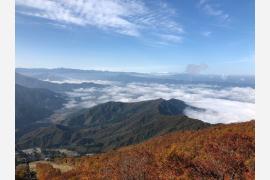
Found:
16,0 -> 184,41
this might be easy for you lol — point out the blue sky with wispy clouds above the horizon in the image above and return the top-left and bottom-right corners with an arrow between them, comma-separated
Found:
16,0 -> 255,75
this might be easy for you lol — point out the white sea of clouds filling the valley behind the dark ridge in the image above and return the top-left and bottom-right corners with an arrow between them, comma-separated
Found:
61,82 -> 255,123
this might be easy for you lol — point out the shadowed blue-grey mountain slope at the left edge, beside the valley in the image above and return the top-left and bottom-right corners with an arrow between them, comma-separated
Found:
15,84 -> 66,129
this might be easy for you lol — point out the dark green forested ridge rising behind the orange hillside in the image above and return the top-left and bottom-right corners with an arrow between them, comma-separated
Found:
16,99 -> 211,153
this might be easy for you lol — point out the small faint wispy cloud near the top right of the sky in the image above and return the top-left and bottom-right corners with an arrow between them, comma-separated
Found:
198,0 -> 231,22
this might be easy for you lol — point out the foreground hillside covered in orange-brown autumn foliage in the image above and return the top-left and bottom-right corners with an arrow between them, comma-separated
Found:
34,121 -> 255,180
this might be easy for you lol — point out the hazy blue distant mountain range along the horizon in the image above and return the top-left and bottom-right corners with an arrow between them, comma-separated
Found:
16,68 -> 255,88
